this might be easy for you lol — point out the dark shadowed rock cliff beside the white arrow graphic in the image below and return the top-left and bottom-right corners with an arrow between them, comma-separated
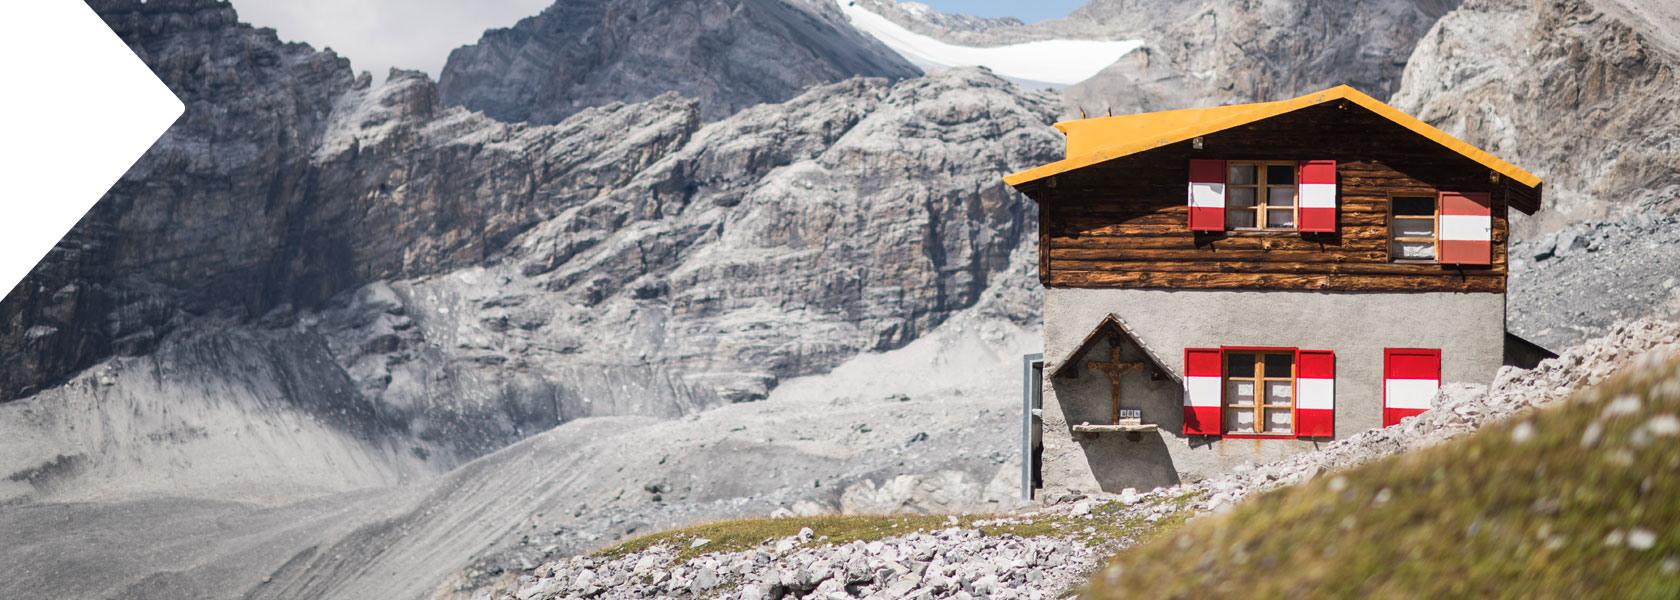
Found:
0,0 -> 356,402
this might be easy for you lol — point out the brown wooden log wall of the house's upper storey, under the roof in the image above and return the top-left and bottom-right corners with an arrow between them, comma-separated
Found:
1023,103 -> 1509,292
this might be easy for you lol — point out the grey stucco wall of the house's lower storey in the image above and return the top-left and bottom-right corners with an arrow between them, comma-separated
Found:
1042,287 -> 1505,491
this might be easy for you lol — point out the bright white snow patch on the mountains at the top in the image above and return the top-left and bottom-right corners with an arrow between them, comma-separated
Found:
835,0 -> 1144,87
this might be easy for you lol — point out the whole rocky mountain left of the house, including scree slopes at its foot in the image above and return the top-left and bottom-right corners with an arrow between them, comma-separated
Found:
0,0 -> 1060,597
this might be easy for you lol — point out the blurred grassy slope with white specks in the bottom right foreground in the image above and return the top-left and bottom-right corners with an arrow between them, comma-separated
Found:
1089,354 -> 1680,600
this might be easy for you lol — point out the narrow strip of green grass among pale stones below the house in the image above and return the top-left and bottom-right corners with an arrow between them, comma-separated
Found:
595,496 -> 1194,563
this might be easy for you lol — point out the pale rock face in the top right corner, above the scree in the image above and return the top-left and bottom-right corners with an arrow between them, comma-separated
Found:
1394,0 -> 1680,239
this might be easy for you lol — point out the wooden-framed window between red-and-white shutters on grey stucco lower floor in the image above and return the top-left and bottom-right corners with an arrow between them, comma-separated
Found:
1221,350 -> 1295,435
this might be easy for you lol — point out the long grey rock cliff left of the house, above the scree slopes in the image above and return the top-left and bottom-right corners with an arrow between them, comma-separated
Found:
0,0 -> 1060,496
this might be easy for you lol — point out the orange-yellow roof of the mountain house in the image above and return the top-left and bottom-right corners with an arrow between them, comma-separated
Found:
1003,86 -> 1541,188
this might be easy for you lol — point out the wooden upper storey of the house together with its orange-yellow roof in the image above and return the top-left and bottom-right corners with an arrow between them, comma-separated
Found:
1006,86 -> 1541,292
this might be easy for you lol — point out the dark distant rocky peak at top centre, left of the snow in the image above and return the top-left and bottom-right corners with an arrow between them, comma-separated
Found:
438,0 -> 919,123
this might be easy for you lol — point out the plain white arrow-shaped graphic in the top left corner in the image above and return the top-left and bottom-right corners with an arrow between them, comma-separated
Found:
0,0 -> 185,299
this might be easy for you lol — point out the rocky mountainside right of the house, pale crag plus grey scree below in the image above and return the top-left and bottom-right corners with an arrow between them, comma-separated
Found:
1394,0 -> 1680,348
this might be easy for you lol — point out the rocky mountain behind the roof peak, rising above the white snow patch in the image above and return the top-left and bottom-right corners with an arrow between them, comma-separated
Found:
846,0 -> 1458,114
